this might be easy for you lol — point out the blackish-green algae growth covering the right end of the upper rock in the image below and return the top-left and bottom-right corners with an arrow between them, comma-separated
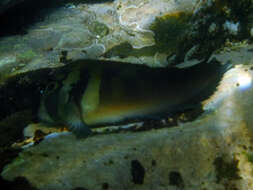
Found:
168,0 -> 253,64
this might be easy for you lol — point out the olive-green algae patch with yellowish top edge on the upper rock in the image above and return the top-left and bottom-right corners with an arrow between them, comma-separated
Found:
104,12 -> 191,58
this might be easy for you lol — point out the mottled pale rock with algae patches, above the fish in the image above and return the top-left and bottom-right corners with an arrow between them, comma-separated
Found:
0,0 -> 252,82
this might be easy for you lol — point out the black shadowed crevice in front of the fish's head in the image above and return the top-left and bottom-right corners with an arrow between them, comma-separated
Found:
0,69 -> 52,120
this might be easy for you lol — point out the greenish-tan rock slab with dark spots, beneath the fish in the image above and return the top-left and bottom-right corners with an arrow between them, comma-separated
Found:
1,65 -> 253,190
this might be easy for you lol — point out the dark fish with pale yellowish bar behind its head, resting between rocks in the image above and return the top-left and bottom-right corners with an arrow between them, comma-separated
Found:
38,60 -> 230,136
